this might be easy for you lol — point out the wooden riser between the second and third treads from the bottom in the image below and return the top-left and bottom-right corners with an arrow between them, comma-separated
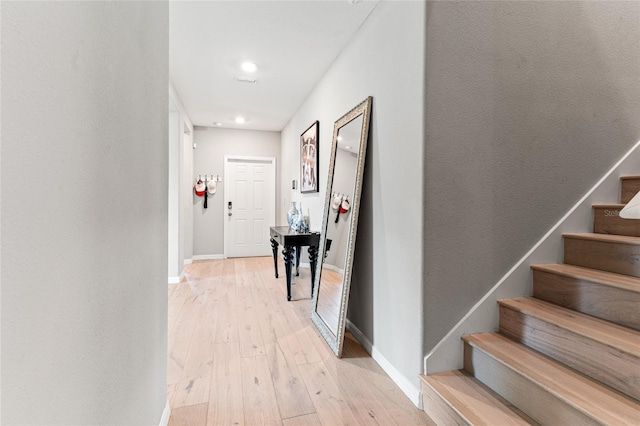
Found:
500,306 -> 640,399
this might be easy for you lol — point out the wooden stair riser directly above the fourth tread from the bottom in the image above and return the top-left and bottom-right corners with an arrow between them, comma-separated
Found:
564,236 -> 640,277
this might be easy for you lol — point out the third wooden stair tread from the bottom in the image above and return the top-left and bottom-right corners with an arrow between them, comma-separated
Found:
498,297 -> 640,357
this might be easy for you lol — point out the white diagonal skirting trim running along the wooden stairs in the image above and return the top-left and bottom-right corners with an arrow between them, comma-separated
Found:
423,141 -> 640,375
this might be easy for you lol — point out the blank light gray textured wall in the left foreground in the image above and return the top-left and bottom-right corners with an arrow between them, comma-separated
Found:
1,2 -> 169,425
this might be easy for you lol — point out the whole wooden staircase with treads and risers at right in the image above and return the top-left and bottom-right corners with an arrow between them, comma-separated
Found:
421,176 -> 640,425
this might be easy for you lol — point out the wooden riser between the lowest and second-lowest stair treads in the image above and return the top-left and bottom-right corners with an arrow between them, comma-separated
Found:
464,343 -> 600,425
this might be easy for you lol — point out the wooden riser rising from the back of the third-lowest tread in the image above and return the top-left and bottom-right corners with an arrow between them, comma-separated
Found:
533,269 -> 640,330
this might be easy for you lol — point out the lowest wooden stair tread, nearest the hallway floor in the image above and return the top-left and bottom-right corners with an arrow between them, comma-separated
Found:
420,370 -> 537,425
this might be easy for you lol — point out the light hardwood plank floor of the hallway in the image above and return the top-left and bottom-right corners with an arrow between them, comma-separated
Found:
167,257 -> 434,426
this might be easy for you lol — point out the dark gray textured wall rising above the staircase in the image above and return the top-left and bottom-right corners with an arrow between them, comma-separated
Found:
424,1 -> 640,353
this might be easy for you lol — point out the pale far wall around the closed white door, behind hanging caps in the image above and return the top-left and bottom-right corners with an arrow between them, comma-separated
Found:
190,127 -> 278,258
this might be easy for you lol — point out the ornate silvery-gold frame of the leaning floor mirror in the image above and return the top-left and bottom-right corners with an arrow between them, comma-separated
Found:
311,96 -> 373,357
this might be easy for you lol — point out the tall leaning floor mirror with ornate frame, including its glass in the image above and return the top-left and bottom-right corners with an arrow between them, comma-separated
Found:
311,97 -> 372,356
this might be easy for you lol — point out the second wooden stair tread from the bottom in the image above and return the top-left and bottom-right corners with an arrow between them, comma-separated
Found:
463,333 -> 640,424
